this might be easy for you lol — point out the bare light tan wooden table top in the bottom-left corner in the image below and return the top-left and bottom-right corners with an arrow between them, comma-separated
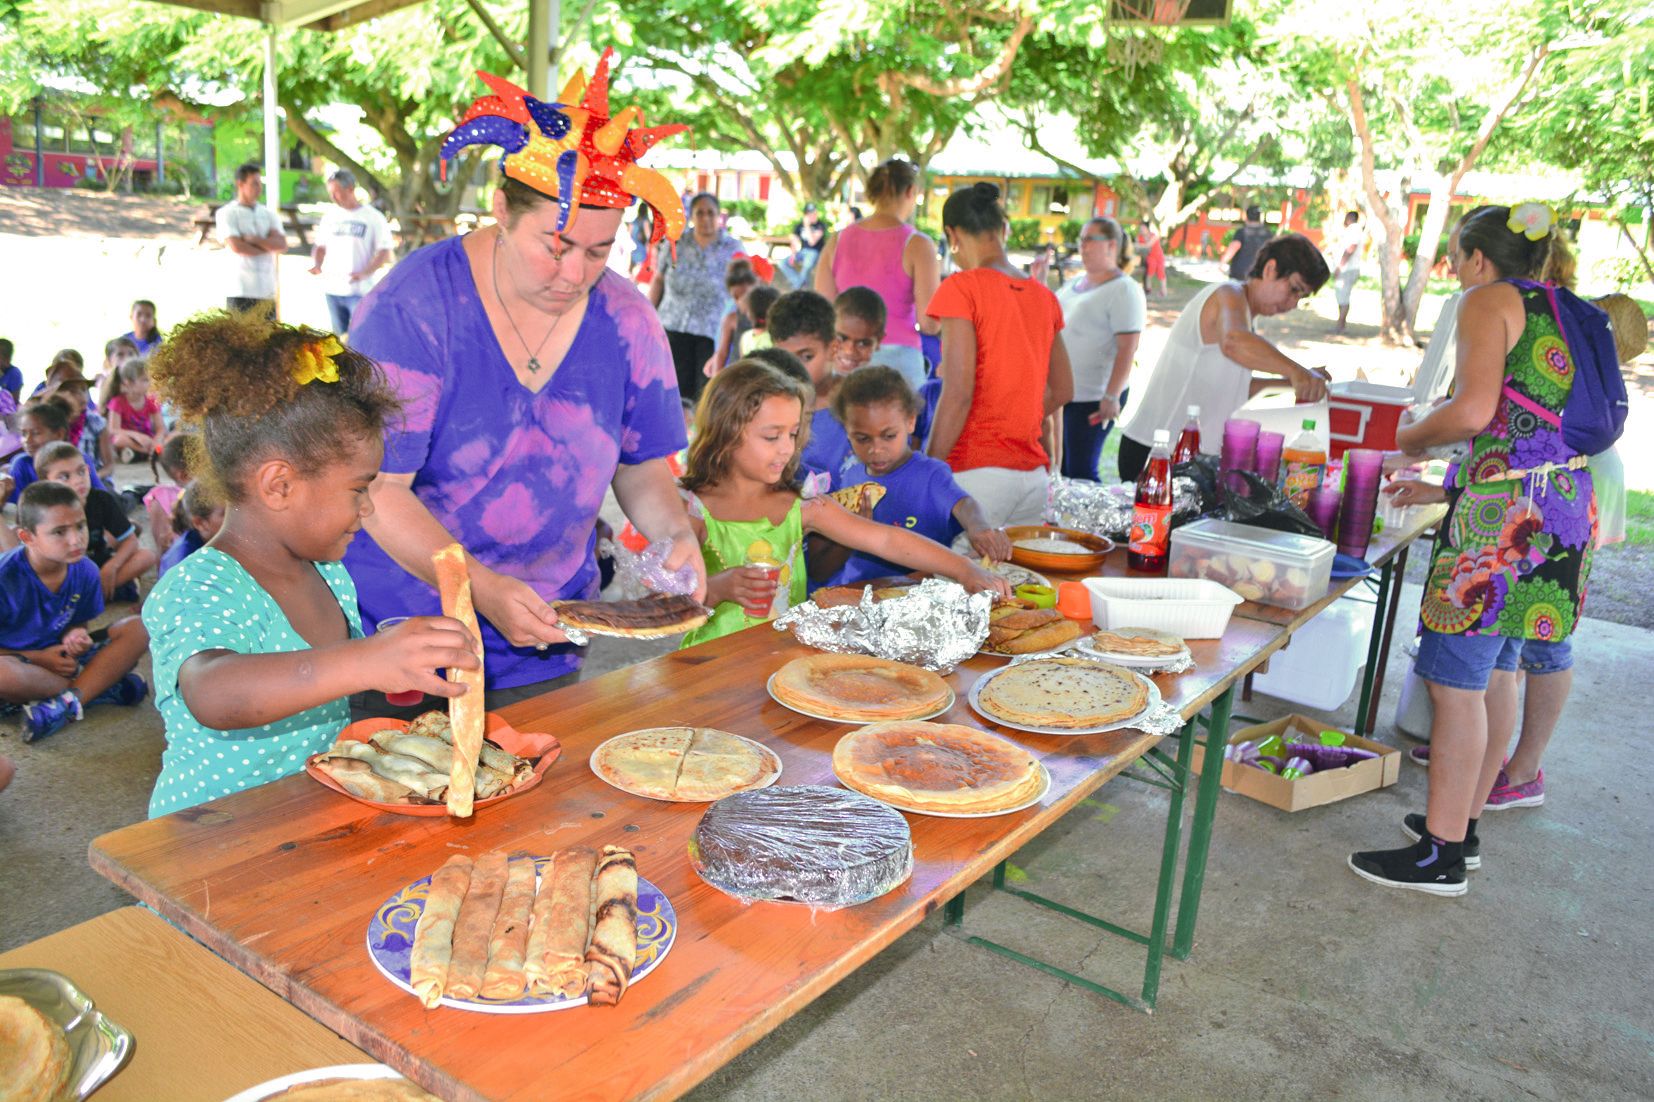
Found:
0,907 -> 374,1102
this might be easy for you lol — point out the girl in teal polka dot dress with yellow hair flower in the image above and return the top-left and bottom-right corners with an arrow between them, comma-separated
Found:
144,313 -> 478,816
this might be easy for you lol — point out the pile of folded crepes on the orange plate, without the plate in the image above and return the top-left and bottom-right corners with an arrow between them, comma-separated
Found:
311,712 -> 534,804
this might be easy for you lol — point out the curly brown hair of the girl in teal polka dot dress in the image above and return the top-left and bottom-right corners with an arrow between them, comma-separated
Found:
149,311 -> 400,503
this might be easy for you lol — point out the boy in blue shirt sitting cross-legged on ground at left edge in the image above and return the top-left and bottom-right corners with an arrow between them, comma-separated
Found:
0,482 -> 149,743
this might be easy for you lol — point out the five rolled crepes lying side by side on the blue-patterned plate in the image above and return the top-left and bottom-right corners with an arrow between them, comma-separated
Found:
409,846 -> 637,1008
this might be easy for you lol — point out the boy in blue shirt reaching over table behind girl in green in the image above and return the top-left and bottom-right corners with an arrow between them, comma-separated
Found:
807,366 -> 1011,586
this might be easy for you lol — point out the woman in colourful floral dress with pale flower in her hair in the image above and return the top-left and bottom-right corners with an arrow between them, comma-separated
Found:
1350,204 -> 1596,895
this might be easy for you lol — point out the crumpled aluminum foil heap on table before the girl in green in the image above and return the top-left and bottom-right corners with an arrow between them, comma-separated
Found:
774,577 -> 994,673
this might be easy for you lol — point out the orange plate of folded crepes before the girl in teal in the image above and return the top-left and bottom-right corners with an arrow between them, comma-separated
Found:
304,712 -> 562,816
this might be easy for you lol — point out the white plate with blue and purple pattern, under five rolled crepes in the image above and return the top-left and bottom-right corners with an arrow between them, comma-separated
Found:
367,857 -> 678,1014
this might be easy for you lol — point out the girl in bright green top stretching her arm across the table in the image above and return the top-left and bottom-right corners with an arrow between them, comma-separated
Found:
681,359 -> 1011,647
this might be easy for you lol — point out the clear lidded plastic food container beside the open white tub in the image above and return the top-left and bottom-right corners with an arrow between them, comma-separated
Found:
1168,520 -> 1335,609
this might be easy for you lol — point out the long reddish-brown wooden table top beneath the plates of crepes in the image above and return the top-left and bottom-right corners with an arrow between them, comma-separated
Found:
91,619 -> 1285,1099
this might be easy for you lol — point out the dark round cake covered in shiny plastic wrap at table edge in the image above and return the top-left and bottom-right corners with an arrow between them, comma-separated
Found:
690,784 -> 913,910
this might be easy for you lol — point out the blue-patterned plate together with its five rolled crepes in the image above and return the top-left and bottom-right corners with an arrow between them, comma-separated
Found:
367,846 -> 678,1014
